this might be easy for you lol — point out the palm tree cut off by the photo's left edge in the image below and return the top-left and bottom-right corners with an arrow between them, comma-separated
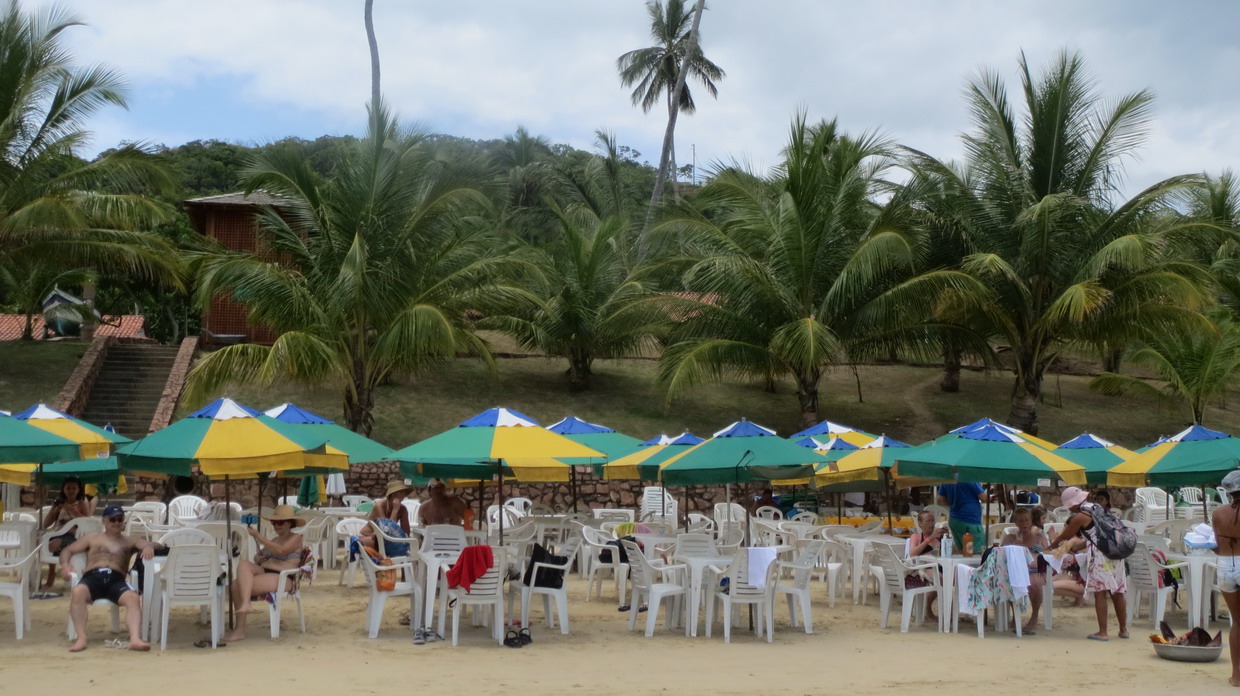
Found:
0,0 -> 180,300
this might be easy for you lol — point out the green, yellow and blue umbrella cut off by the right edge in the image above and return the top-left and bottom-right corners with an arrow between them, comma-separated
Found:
1106,426 -> 1240,488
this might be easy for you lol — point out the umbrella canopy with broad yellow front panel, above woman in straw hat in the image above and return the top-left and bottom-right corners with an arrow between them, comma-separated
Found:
117,398 -> 327,476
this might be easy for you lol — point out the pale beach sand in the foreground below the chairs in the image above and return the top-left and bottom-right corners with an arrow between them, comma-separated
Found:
0,571 -> 1235,696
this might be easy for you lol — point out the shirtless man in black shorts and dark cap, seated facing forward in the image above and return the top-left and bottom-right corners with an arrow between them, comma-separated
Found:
61,505 -> 159,653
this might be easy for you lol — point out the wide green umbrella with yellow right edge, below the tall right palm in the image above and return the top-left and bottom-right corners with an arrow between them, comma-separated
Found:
894,424 -> 1085,486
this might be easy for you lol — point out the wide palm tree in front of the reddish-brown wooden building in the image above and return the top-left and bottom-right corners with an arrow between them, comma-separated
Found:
190,103 -> 527,434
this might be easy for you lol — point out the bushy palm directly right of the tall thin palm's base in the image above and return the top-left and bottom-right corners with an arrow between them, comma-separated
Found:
660,114 -> 982,423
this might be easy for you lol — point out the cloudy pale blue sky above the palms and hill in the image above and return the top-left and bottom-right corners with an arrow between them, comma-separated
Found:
55,0 -> 1240,196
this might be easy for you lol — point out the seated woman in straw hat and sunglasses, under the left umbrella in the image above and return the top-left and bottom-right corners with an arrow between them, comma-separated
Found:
223,505 -> 306,643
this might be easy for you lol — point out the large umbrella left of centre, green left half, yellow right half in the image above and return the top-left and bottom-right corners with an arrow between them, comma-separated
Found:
392,408 -> 606,543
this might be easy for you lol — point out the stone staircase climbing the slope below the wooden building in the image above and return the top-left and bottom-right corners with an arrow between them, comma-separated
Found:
81,344 -> 179,439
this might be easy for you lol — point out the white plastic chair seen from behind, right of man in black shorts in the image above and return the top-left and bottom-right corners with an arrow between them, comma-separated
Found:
157,543 -> 223,650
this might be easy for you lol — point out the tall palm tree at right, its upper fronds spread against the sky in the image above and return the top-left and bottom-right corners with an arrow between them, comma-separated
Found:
915,52 -> 1208,433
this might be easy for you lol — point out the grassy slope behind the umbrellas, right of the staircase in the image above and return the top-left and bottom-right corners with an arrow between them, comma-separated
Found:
198,357 -> 1240,447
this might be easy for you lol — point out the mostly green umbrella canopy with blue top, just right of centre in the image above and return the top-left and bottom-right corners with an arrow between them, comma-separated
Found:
660,421 -> 823,486
